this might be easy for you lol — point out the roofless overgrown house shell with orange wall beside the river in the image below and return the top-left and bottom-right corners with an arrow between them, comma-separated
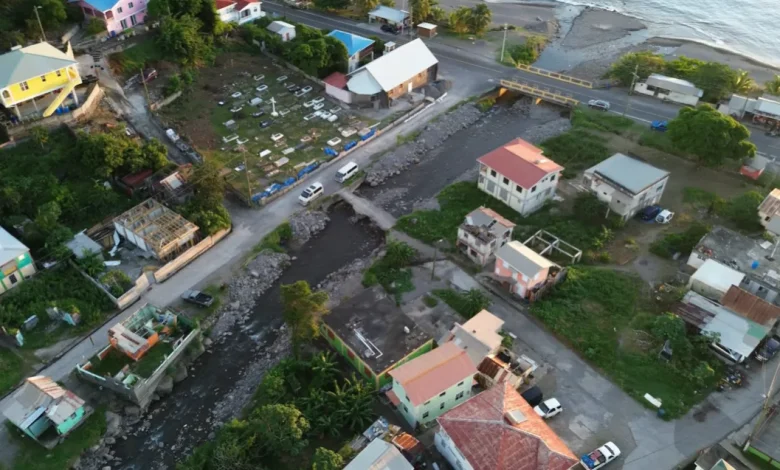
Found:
76,304 -> 200,407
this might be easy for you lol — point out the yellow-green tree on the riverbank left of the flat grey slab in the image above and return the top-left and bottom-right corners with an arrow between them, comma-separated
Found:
281,281 -> 328,355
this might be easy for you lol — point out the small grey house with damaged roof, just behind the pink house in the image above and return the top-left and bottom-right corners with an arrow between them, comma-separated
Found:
458,207 -> 515,266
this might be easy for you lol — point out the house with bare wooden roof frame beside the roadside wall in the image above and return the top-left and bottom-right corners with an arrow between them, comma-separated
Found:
114,199 -> 198,260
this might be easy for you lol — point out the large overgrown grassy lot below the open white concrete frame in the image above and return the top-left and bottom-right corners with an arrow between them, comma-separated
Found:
531,267 -> 722,419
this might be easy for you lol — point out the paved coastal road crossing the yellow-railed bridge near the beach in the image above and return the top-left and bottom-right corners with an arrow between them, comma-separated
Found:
263,2 -> 780,157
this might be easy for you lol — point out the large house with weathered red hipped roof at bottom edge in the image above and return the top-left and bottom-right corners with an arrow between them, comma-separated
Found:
435,383 -> 578,470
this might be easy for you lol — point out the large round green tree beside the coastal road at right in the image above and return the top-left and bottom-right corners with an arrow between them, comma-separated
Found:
668,104 -> 756,166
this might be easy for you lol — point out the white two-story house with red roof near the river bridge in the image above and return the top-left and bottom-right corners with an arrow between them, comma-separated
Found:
477,139 -> 563,215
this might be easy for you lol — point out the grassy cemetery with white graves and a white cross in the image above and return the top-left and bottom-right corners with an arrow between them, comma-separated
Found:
158,53 -> 374,197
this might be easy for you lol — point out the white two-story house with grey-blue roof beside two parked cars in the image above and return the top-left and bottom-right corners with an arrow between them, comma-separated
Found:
583,153 -> 669,220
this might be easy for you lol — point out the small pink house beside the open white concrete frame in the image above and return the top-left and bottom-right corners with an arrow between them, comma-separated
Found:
493,240 -> 561,298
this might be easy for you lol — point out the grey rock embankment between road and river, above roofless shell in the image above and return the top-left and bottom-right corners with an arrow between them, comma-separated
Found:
206,250 -> 290,341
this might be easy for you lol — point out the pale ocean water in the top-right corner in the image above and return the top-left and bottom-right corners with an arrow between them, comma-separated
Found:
557,0 -> 780,67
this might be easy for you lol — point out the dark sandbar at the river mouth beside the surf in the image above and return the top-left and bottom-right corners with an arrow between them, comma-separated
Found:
563,8 -> 646,48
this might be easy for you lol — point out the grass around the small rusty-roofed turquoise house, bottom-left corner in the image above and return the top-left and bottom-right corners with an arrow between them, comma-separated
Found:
7,406 -> 106,470
